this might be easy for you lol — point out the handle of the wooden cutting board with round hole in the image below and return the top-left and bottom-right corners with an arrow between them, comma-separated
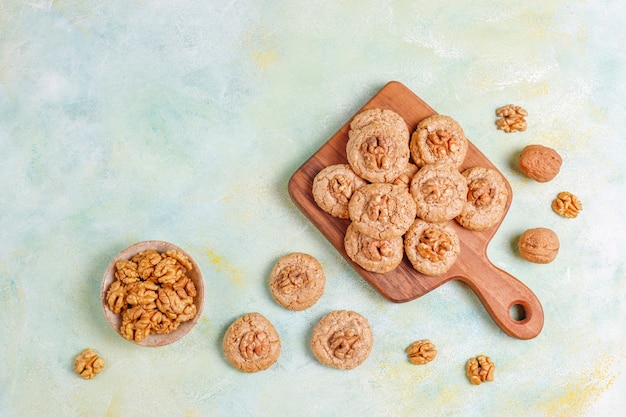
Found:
458,262 -> 543,339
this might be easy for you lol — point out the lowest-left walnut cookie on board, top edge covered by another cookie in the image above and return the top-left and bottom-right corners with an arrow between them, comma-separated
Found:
344,223 -> 404,274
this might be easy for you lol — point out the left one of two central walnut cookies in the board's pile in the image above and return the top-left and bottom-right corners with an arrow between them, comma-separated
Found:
348,183 -> 416,240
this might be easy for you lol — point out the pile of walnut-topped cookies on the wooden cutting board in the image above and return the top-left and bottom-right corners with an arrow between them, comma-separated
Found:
312,108 -> 508,275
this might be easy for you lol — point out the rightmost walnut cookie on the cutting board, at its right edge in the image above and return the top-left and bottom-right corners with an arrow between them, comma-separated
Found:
456,167 -> 509,230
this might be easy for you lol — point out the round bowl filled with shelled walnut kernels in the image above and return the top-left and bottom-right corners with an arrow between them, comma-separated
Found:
100,240 -> 204,347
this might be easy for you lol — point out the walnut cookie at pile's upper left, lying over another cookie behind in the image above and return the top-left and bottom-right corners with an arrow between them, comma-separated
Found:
346,122 -> 410,182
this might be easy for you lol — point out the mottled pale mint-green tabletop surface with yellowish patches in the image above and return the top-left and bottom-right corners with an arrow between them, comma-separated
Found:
0,0 -> 626,417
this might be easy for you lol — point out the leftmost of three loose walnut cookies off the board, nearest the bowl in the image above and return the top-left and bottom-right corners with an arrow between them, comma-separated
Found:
222,313 -> 280,373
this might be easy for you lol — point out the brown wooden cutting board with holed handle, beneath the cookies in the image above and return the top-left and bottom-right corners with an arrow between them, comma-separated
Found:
288,81 -> 543,339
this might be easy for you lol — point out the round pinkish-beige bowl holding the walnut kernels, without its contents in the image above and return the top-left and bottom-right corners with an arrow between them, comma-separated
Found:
100,240 -> 204,347
